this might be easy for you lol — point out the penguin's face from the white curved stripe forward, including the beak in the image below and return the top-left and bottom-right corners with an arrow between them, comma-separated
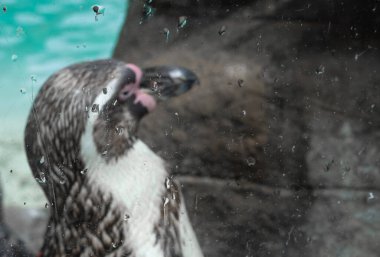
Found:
82,61 -> 198,159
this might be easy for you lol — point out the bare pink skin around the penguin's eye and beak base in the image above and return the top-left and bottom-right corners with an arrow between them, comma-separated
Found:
119,63 -> 157,112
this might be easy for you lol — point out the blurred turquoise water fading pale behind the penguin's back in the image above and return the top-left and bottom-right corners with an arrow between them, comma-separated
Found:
0,0 -> 127,205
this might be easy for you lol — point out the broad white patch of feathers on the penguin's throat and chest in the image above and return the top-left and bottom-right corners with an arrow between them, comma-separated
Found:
82,137 -> 168,257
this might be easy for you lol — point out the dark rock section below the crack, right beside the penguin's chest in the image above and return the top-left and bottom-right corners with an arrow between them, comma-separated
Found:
180,177 -> 312,256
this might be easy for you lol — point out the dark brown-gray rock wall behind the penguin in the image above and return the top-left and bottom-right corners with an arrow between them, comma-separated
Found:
114,0 -> 380,257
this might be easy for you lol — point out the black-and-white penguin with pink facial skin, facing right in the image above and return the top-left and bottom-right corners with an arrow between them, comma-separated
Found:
24,59 -> 203,257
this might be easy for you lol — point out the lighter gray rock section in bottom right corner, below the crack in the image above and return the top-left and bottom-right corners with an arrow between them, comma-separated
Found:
300,190 -> 380,257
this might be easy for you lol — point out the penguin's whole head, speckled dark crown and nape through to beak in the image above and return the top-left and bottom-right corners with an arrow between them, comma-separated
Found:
25,60 -> 198,190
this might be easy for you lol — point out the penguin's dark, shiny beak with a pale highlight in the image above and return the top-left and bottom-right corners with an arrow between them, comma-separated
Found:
140,66 -> 199,100
